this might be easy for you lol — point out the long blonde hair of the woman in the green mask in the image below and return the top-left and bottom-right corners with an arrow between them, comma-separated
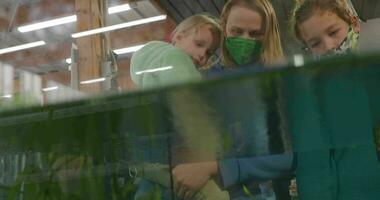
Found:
221,0 -> 284,67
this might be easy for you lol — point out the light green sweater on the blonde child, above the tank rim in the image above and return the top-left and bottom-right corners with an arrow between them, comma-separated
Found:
130,41 -> 201,89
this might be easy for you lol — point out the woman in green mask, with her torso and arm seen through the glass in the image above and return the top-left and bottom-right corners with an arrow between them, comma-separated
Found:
173,0 -> 292,198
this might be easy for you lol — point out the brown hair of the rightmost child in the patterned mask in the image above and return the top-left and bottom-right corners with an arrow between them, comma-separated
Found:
290,0 -> 355,42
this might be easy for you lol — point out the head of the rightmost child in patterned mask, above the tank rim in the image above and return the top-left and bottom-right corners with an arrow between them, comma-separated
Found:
291,0 -> 360,55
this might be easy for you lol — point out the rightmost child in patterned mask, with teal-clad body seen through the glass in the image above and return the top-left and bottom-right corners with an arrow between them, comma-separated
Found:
288,0 -> 380,199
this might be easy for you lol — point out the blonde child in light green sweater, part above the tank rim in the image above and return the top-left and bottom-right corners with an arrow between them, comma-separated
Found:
130,14 -> 221,88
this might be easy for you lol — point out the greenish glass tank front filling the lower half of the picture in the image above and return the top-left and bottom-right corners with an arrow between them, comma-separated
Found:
0,52 -> 380,199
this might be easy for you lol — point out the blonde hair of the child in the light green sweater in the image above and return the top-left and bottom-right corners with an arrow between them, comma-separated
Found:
171,14 -> 222,47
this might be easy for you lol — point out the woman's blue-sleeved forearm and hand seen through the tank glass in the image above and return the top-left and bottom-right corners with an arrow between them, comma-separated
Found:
173,154 -> 293,195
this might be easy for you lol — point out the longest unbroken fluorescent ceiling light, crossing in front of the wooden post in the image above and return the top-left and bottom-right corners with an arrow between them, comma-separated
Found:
71,15 -> 166,38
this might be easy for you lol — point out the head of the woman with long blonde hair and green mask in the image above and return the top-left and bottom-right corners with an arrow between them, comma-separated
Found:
221,0 -> 283,68
